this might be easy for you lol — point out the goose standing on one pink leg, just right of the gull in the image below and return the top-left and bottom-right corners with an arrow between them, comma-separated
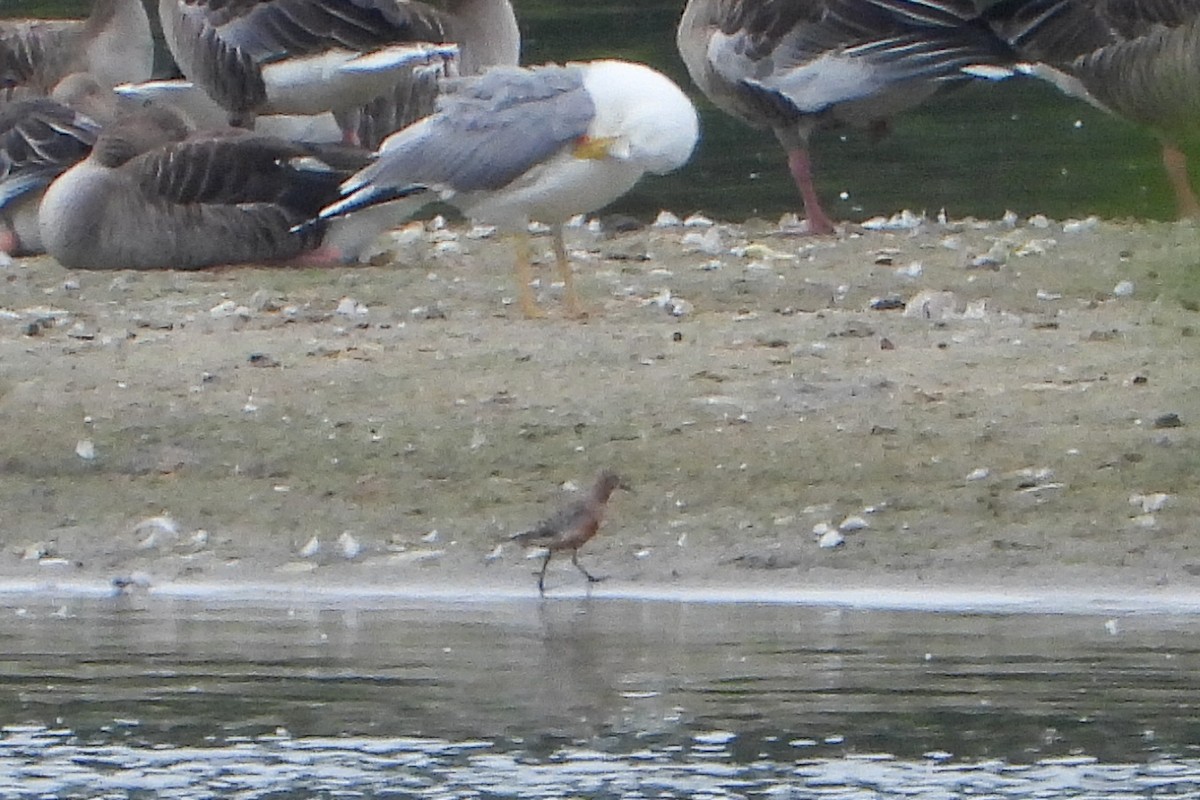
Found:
676,0 -> 1010,234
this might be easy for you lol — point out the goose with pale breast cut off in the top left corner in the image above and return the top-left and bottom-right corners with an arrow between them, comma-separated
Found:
0,0 -> 154,95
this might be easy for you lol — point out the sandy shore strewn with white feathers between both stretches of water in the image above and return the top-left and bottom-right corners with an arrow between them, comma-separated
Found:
0,212 -> 1200,599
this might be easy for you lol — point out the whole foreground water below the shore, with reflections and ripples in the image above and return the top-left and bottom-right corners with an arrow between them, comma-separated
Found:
0,597 -> 1200,798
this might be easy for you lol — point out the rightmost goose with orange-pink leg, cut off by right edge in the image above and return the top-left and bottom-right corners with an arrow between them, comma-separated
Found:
989,0 -> 1200,219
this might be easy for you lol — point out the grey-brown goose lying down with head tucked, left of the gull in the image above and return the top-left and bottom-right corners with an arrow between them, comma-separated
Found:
40,107 -> 379,270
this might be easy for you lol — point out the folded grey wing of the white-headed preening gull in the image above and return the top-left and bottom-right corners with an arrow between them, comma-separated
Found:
357,66 -> 595,193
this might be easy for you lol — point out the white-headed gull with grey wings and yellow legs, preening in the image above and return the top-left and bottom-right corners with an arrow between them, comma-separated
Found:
318,60 -> 700,317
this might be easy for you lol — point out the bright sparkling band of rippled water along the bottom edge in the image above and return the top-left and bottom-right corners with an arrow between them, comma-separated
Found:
0,726 -> 1200,800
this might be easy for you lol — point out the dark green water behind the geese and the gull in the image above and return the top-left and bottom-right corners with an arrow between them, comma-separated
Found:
0,0 -> 1174,219
